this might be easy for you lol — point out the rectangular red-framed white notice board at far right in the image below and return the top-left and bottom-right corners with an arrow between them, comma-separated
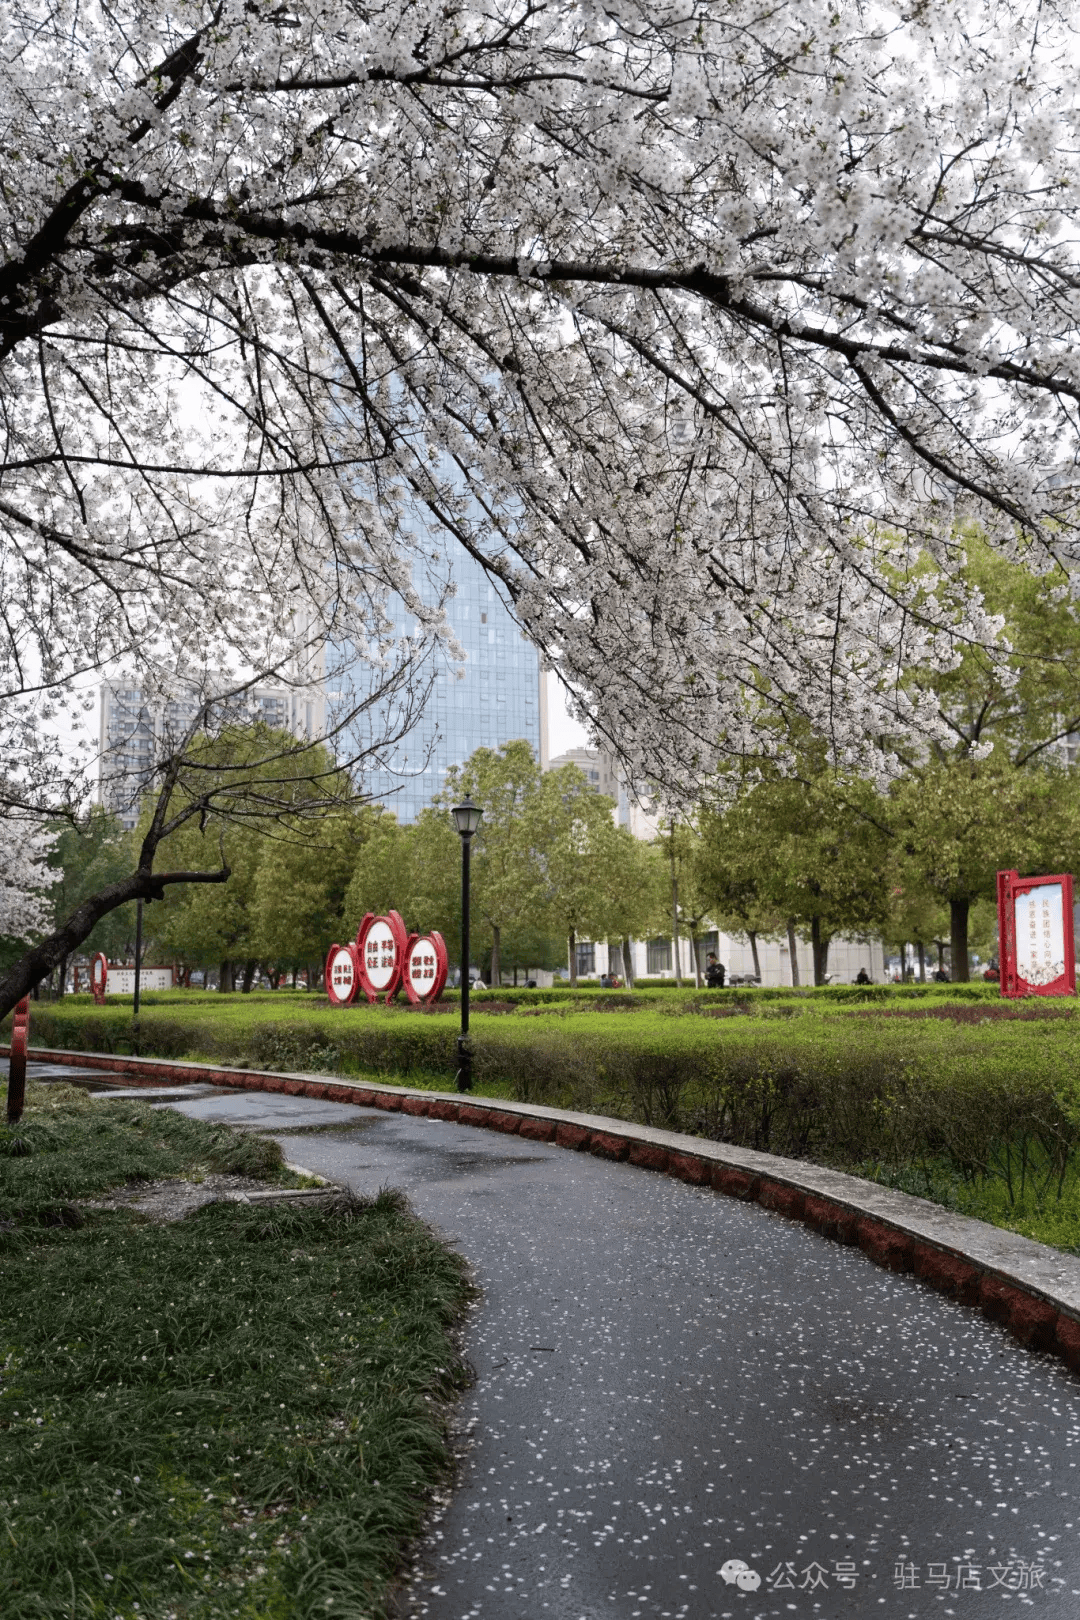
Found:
997,872 -> 1077,996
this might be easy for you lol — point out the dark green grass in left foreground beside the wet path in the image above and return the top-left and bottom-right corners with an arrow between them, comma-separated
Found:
0,1085 -> 468,1620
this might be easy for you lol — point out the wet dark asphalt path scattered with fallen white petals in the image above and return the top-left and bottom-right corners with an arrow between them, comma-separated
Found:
61,1090 -> 1080,1620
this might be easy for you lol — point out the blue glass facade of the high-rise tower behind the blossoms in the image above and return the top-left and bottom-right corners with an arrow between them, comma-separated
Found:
356,552 -> 541,823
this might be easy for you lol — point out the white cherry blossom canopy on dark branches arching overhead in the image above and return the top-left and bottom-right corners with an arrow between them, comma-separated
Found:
0,0 -> 1080,1010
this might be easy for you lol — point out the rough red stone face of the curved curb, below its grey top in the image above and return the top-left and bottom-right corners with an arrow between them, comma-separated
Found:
14,1047 -> 1080,1374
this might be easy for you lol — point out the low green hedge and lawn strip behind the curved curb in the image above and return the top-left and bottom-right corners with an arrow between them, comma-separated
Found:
10,983 -> 1080,1252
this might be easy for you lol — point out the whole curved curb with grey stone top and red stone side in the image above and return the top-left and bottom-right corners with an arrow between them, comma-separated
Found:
14,1047 -> 1080,1372
